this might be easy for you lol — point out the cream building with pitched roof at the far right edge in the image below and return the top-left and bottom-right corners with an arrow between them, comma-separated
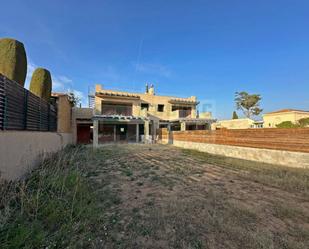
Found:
263,109 -> 309,128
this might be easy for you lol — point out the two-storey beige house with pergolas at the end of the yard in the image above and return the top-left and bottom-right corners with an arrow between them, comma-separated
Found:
73,85 -> 215,146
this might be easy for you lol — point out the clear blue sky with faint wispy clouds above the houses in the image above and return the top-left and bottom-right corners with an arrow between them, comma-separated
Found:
0,0 -> 309,119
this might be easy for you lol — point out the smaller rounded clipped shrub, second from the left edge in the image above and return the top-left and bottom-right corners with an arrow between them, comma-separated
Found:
30,68 -> 52,101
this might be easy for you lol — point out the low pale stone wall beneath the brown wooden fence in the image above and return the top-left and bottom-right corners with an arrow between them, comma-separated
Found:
172,140 -> 309,169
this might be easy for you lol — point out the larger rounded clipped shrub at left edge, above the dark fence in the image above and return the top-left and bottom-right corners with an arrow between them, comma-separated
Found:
0,38 -> 27,86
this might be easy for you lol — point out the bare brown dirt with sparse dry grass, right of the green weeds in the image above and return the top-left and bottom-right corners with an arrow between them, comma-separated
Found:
86,145 -> 309,249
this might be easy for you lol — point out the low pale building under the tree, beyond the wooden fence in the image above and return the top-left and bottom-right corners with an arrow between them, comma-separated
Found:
212,118 -> 263,130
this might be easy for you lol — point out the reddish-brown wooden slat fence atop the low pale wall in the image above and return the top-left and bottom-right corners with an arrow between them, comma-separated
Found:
158,128 -> 309,153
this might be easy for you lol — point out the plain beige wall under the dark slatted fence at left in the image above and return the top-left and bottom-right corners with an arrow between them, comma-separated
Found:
0,131 -> 72,180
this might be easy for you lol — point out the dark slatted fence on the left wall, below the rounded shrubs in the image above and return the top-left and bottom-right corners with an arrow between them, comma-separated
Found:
0,74 -> 57,131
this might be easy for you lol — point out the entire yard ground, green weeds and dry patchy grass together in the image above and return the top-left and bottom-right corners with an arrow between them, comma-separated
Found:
0,145 -> 309,249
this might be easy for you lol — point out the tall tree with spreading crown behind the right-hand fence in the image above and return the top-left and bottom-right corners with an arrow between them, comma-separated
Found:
235,92 -> 263,118
